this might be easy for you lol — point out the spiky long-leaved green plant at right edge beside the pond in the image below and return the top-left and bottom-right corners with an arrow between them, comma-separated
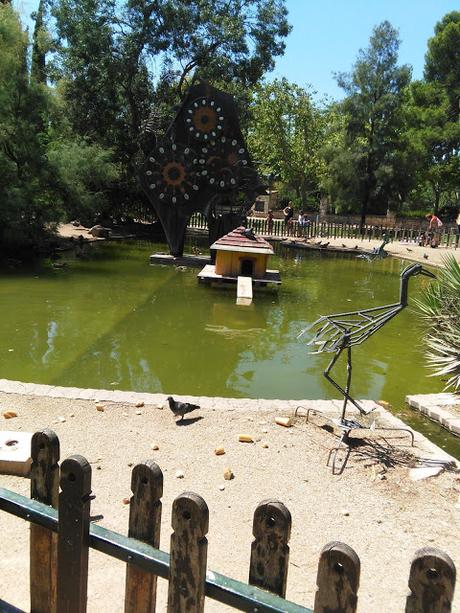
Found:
417,255 -> 460,391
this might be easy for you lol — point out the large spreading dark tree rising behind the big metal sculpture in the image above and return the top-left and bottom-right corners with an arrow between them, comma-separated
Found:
52,0 -> 289,218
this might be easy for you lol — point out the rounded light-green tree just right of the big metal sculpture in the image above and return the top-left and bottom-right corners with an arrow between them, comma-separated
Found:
247,79 -> 325,207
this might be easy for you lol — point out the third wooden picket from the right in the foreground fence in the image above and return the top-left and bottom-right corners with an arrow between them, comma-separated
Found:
249,500 -> 292,597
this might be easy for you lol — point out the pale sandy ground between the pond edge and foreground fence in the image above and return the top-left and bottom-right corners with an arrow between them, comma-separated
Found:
0,392 -> 460,613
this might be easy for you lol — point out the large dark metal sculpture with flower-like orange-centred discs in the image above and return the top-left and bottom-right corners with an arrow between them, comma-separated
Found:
139,82 -> 265,256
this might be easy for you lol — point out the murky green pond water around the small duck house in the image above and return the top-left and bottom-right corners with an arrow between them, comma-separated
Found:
0,242 -> 460,456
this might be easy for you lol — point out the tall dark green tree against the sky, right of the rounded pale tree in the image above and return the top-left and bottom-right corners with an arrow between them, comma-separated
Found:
329,21 -> 411,230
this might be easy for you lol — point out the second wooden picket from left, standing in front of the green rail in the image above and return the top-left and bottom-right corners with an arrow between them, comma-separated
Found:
57,455 -> 91,613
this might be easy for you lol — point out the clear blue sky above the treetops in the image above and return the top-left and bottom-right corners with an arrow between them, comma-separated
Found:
14,0 -> 460,98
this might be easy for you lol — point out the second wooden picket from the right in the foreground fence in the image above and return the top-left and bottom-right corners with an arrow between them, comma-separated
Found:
314,541 -> 361,613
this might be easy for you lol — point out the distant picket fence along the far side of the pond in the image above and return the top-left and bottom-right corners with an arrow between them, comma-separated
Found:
188,213 -> 460,248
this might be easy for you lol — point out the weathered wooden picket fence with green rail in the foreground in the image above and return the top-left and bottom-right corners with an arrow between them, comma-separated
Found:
0,430 -> 456,613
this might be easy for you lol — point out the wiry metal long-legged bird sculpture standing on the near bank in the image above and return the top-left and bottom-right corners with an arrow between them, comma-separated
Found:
299,264 -> 436,472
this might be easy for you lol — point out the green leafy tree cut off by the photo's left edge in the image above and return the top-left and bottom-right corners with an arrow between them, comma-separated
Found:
0,5 -> 59,246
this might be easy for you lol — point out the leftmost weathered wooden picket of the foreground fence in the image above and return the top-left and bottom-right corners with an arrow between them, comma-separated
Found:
30,430 -> 59,613
